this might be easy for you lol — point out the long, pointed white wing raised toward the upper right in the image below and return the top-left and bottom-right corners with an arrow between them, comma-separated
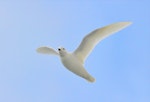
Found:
74,22 -> 131,63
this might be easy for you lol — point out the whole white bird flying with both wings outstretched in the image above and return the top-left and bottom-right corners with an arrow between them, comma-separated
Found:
37,22 -> 131,82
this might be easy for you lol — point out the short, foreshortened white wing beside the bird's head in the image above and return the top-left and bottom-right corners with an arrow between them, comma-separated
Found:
36,46 -> 59,55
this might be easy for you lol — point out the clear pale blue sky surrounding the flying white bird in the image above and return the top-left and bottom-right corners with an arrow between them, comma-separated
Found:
0,0 -> 150,102
